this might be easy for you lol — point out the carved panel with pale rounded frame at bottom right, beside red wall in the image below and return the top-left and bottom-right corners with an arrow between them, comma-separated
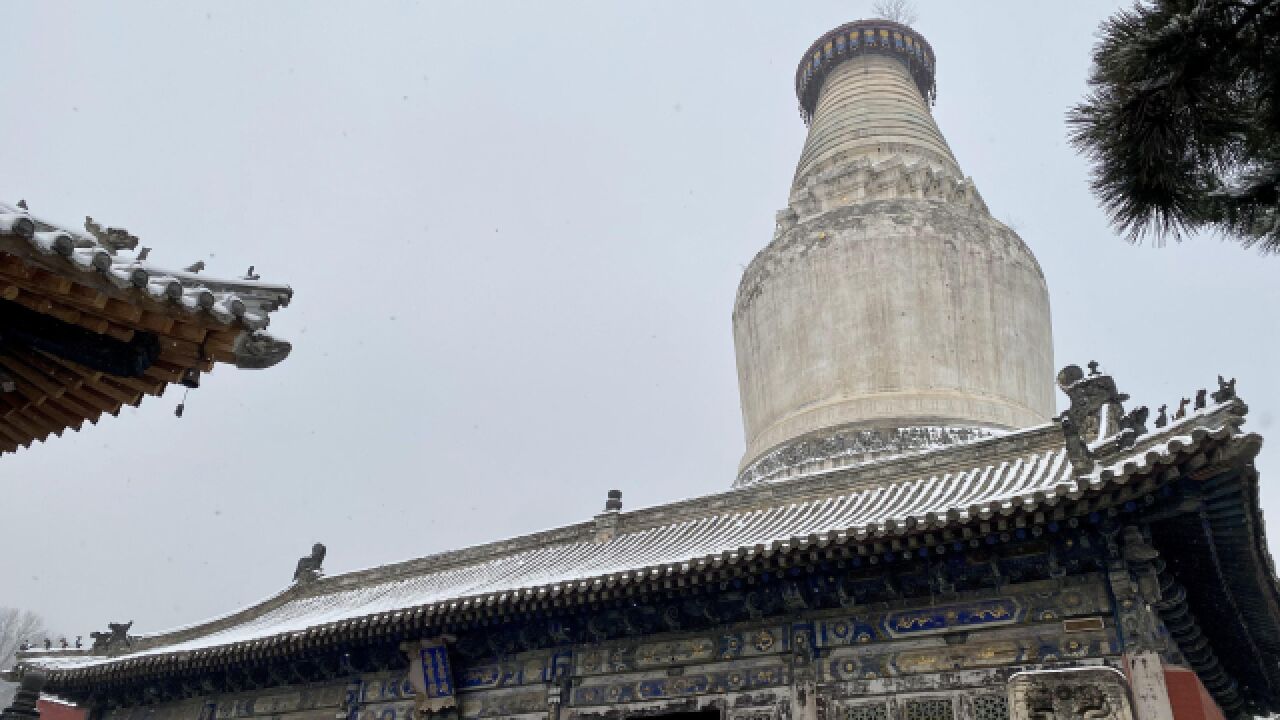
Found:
1009,667 -> 1133,720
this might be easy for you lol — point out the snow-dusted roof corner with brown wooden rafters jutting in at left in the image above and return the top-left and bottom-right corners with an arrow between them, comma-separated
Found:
0,202 -> 293,452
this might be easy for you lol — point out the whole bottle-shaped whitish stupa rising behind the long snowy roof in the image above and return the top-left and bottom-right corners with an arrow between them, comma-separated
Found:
733,20 -> 1055,486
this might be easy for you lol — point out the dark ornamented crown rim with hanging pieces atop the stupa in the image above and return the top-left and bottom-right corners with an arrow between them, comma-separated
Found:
796,20 -> 937,124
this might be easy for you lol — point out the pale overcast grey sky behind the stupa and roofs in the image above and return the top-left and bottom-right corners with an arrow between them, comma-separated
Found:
0,0 -> 1280,635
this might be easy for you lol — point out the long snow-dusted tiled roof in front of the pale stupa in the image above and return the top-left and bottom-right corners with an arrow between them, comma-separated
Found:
23,389 -> 1274,687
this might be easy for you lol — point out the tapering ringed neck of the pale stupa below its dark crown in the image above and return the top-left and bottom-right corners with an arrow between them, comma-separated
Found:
792,54 -> 964,192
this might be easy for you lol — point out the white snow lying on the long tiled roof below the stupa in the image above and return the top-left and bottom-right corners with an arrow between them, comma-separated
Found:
36,401 -> 1243,673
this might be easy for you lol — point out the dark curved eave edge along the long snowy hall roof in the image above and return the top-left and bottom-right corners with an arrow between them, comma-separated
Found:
24,407 -> 1254,693
